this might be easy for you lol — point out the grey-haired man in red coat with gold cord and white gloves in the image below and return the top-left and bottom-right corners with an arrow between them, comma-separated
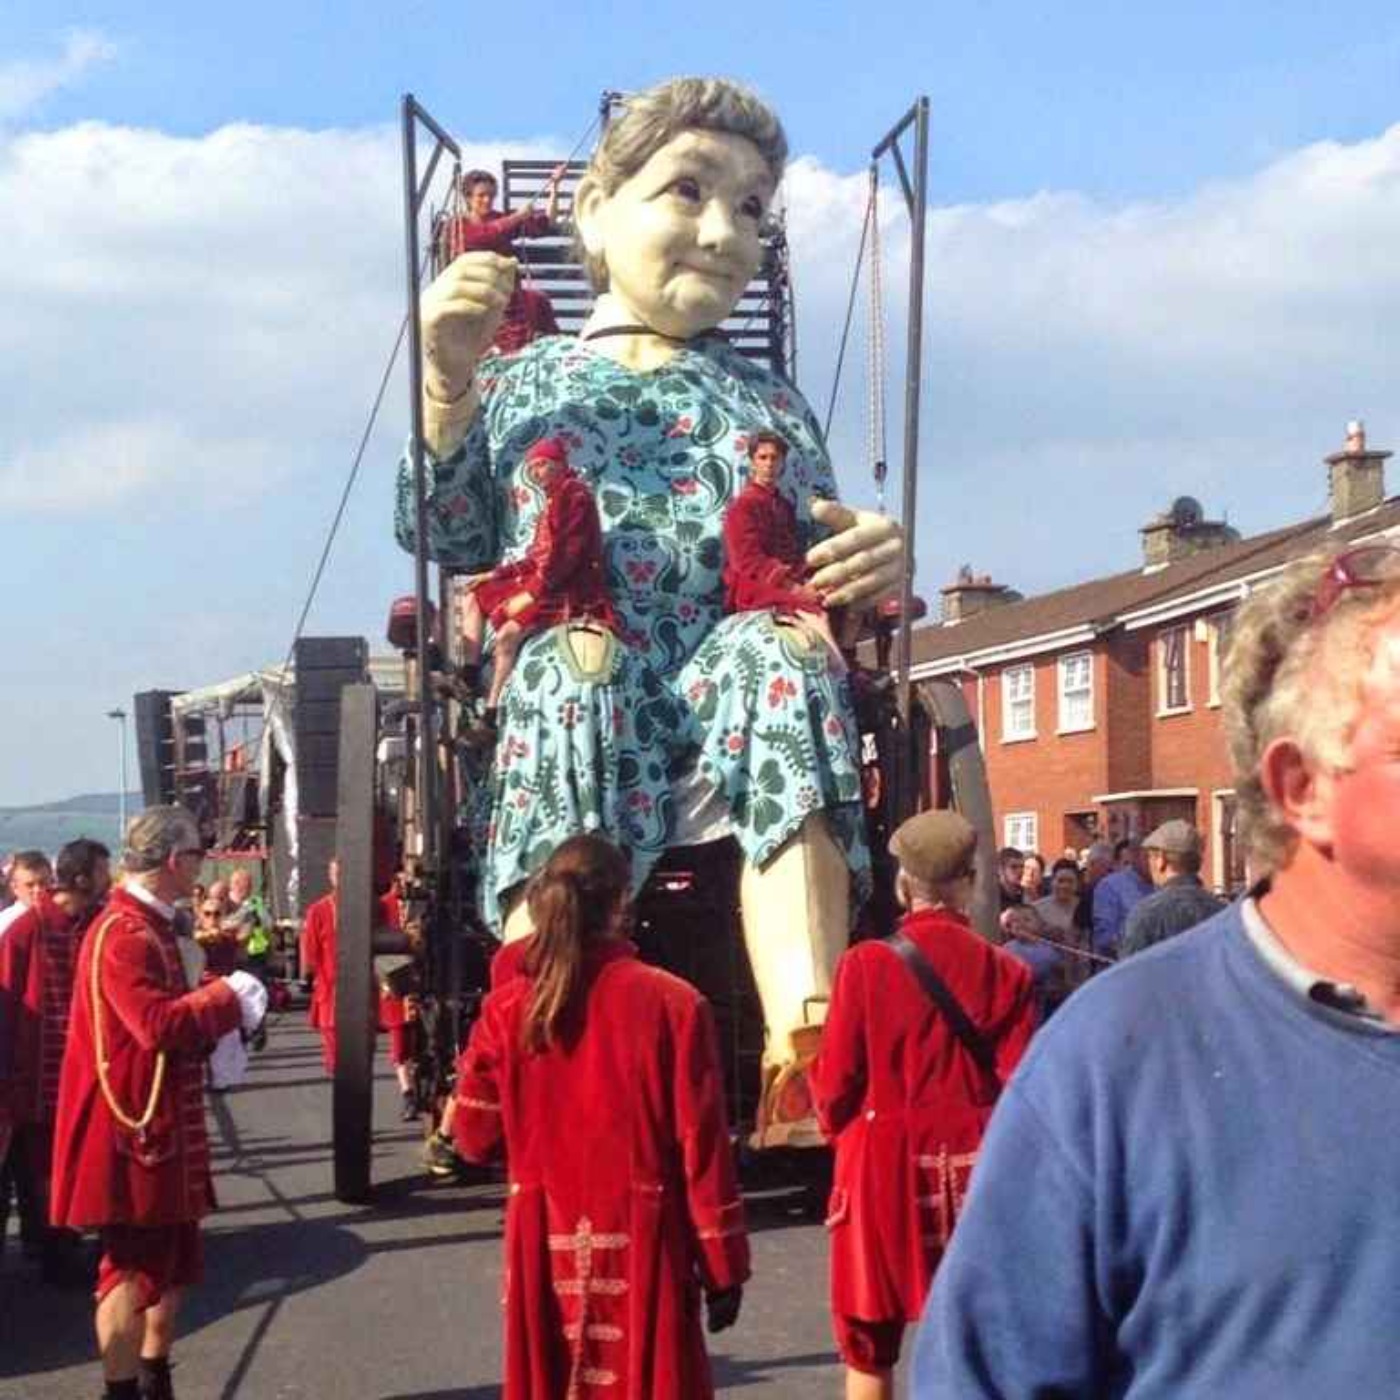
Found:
52,806 -> 267,1400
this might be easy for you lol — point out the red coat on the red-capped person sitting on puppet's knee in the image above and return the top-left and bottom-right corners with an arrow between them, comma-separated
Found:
476,468 -> 617,631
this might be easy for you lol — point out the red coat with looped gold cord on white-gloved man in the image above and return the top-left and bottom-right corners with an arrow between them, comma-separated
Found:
52,889 -> 241,1229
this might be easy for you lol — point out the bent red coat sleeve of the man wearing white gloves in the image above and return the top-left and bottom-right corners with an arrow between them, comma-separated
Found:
98,925 -> 242,1053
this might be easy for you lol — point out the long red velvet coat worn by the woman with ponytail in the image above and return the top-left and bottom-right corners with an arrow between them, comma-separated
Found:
454,942 -> 749,1400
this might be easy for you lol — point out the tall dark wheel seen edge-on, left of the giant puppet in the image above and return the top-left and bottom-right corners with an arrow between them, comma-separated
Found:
332,685 -> 378,1203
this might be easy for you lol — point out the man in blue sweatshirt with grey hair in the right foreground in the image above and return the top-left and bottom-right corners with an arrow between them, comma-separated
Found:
913,547 -> 1400,1400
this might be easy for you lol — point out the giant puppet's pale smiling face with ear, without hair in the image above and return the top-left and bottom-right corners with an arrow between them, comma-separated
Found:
574,132 -> 774,340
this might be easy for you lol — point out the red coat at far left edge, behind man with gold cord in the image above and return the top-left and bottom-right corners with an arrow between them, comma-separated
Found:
0,890 -> 83,1127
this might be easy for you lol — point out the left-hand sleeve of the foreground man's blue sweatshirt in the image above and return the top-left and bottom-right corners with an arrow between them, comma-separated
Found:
911,1065 -> 1117,1400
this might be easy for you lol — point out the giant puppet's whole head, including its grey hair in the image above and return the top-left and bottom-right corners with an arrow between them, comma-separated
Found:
574,78 -> 787,340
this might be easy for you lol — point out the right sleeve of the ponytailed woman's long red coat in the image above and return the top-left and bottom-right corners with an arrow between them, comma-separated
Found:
675,1000 -> 749,1292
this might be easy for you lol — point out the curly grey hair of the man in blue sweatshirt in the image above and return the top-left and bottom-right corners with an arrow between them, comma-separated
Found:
1221,553 -> 1400,871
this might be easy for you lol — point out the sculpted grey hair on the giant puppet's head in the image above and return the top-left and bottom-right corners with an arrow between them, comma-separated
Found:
575,78 -> 788,291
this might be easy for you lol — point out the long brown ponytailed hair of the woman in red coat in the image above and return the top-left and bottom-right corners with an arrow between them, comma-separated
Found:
521,836 -> 629,1053
